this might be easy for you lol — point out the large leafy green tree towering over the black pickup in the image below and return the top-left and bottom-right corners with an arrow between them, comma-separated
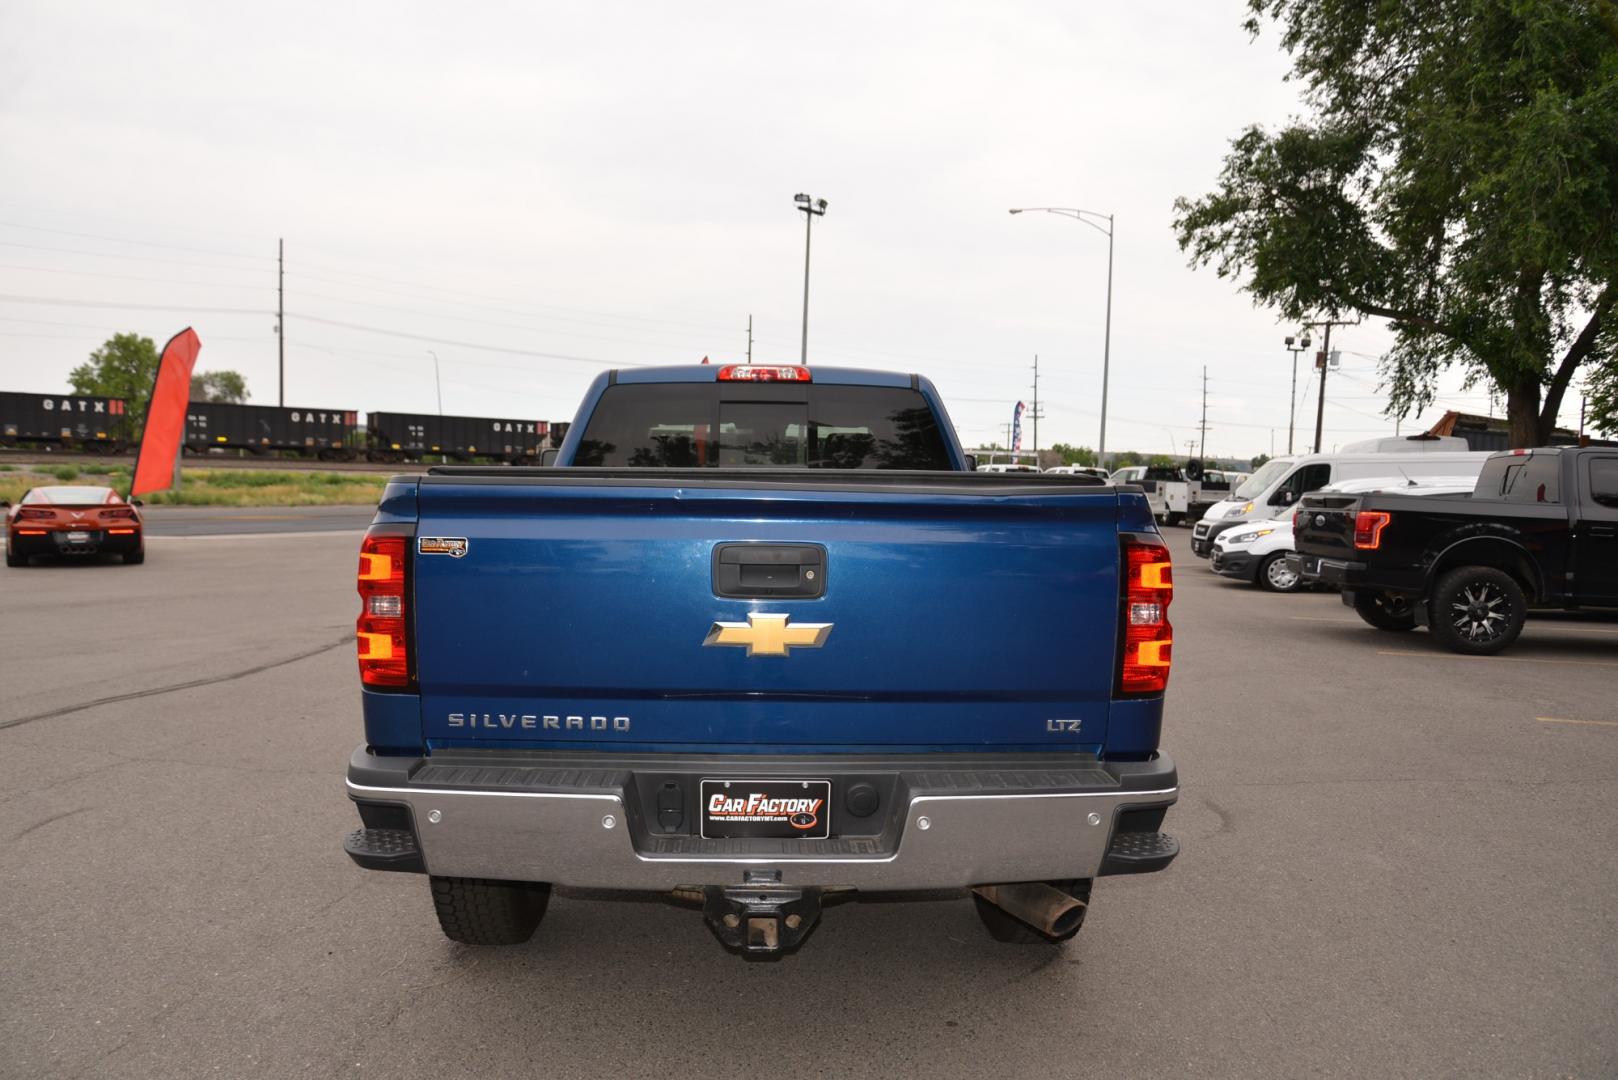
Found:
1175,0 -> 1618,447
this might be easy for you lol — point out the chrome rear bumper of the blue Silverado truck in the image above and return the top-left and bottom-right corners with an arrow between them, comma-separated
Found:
348,755 -> 1180,891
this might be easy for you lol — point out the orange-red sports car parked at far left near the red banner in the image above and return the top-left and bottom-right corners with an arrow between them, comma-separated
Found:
0,484 -> 146,567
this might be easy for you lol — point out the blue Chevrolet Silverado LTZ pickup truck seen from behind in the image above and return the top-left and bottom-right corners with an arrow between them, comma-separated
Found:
345,366 -> 1180,955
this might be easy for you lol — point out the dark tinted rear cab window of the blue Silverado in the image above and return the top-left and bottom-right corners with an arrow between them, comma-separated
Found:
573,382 -> 953,471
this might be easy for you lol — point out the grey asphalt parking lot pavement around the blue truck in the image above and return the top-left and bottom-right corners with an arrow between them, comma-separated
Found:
0,512 -> 1618,1077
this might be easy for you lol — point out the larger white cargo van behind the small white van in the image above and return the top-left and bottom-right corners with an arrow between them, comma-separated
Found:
1191,439 -> 1489,559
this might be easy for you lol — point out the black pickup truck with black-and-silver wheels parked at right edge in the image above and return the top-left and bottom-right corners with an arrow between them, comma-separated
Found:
1293,447 -> 1618,654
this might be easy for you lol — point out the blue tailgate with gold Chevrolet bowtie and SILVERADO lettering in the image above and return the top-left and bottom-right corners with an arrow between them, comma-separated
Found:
413,470 -> 1120,753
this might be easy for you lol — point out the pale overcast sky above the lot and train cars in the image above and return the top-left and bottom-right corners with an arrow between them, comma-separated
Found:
0,0 -> 1578,457
